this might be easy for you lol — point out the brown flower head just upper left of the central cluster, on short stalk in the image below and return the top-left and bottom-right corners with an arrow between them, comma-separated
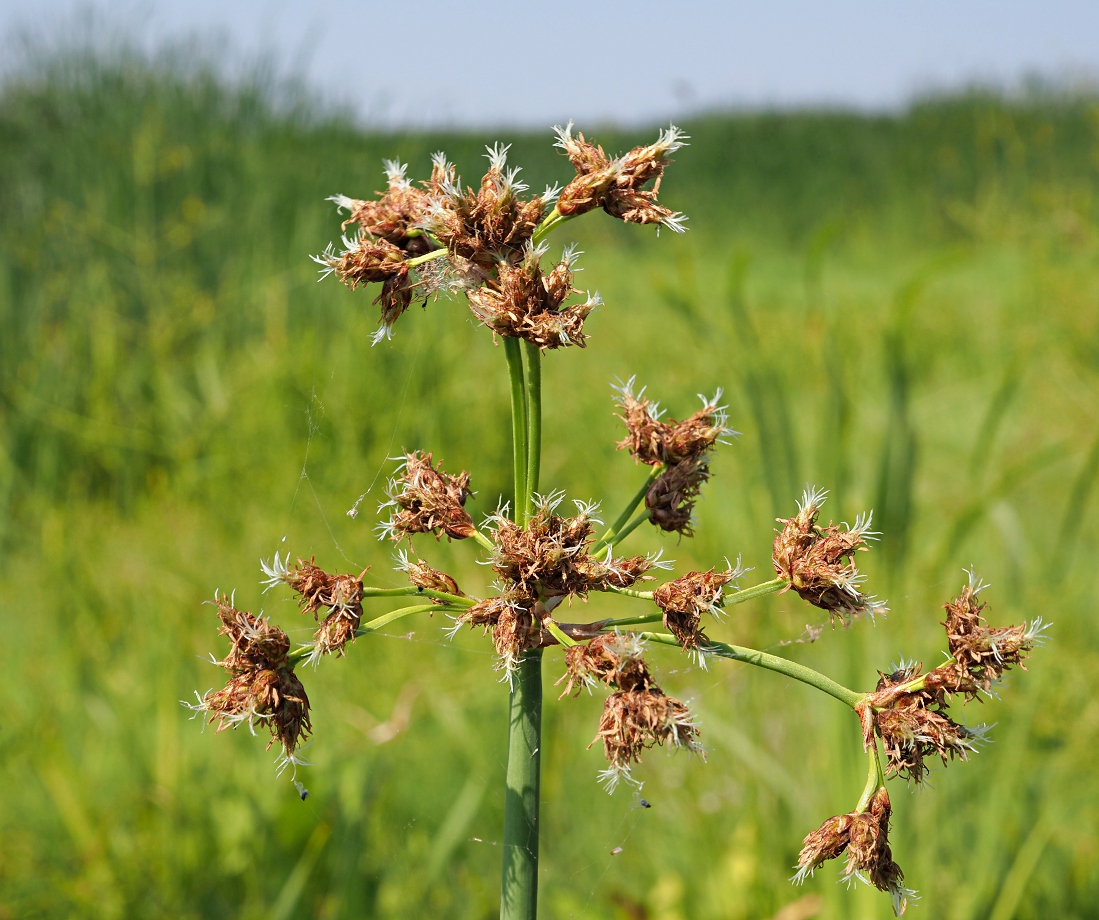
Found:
378,451 -> 476,542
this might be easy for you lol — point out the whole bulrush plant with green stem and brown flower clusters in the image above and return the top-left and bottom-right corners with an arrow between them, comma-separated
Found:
184,125 -> 1043,920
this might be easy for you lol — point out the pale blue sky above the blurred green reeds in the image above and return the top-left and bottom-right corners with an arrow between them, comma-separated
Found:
0,0 -> 1099,125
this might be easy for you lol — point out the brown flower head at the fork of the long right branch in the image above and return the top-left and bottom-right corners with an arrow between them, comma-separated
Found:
863,662 -> 988,783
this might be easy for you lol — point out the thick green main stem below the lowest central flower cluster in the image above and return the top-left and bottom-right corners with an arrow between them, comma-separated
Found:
500,649 -> 542,920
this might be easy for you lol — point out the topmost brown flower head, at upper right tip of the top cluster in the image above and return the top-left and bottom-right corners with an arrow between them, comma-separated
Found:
554,122 -> 687,233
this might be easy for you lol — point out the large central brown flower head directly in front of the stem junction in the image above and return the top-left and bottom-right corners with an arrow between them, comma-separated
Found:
489,492 -> 665,598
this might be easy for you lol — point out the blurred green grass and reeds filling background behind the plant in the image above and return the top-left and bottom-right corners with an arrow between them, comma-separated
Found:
0,55 -> 1099,920
